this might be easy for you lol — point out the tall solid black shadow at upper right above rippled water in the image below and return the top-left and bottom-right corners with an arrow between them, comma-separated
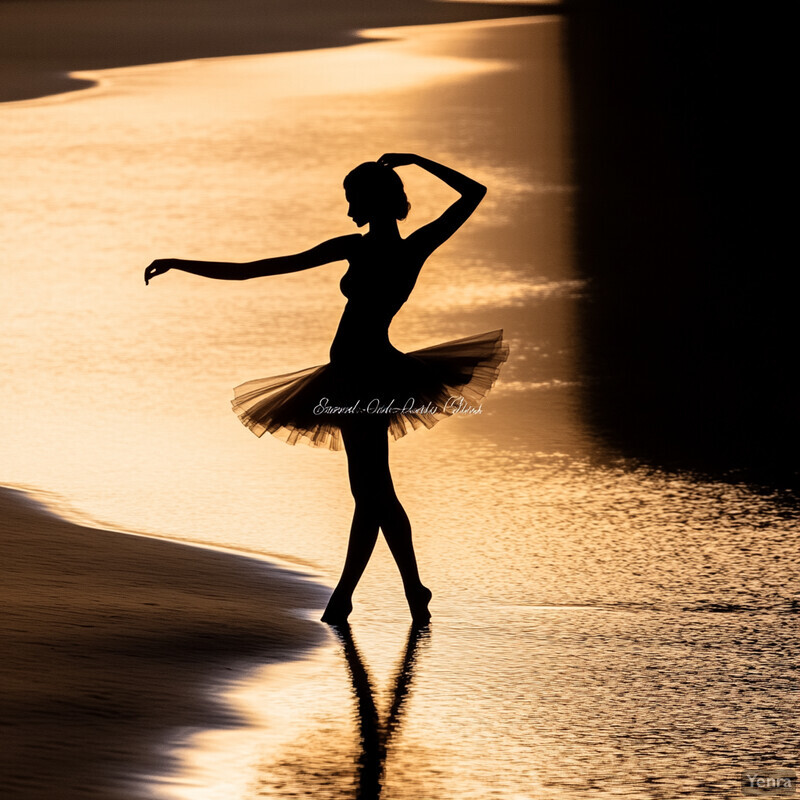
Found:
567,0 -> 798,484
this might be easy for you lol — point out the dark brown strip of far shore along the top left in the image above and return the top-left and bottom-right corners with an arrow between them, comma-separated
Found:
0,0 -> 558,103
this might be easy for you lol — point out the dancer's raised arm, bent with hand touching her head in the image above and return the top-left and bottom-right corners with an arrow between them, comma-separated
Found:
378,153 -> 486,254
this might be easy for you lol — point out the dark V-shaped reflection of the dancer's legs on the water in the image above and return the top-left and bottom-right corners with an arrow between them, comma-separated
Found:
332,623 -> 430,800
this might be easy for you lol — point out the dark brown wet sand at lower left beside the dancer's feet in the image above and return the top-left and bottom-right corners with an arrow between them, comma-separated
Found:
0,489 -> 326,800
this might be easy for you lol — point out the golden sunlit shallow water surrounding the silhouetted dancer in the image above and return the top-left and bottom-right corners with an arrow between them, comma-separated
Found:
0,17 -> 798,800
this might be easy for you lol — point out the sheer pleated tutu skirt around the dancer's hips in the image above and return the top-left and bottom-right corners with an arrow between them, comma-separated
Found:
232,330 -> 508,450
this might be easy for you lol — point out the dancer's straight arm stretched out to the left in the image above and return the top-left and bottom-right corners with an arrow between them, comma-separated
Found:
144,233 -> 361,284
